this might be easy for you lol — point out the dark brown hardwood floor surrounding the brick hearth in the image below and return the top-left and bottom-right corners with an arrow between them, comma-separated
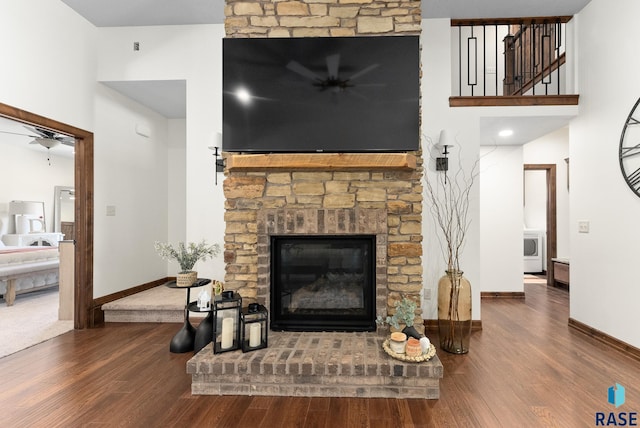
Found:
0,284 -> 640,427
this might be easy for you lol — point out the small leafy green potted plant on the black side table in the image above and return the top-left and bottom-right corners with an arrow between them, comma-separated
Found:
153,239 -> 220,287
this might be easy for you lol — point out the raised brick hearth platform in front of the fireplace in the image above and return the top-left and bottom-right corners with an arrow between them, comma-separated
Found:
187,332 -> 443,399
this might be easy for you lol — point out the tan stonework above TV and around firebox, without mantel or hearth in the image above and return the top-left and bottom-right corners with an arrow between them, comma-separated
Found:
224,0 -> 422,327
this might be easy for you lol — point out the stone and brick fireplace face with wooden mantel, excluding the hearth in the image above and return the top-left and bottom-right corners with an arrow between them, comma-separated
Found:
224,160 -> 422,330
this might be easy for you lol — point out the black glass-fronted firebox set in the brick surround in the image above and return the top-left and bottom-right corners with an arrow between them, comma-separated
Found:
271,235 -> 376,331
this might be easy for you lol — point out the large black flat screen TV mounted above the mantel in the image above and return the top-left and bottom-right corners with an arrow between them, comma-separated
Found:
222,36 -> 420,153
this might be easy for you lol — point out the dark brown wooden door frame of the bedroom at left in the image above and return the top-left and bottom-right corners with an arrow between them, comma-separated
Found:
0,103 -> 94,329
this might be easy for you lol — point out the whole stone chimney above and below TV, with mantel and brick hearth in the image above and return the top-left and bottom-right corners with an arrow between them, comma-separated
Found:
187,0 -> 442,398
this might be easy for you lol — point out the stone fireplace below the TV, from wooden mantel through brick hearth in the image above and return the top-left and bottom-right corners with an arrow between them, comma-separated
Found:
187,162 -> 443,399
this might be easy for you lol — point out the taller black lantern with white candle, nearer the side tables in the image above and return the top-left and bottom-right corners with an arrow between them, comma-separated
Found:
213,291 -> 242,354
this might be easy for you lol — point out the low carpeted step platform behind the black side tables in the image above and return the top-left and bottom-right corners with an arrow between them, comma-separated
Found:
102,285 -> 203,323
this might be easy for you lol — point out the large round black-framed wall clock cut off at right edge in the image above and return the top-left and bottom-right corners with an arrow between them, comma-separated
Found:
618,98 -> 640,197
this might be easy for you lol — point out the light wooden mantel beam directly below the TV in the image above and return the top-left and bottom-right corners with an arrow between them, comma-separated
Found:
225,153 -> 416,171
